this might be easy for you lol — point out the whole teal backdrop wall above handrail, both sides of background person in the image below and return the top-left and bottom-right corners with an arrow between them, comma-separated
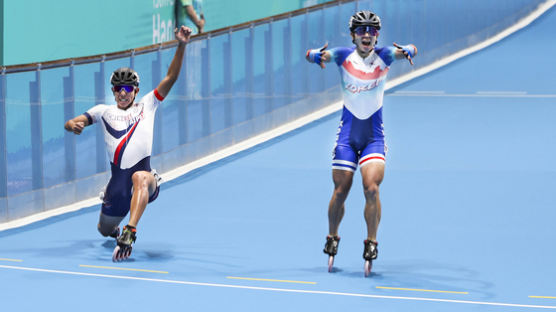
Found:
0,0 -> 326,66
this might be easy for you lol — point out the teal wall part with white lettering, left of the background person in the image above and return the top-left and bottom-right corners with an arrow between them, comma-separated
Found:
3,0 -> 173,65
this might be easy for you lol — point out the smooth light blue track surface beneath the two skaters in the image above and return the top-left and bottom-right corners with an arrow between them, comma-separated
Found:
0,5 -> 556,312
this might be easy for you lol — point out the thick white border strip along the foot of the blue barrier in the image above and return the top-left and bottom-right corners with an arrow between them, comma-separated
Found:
0,0 -> 556,231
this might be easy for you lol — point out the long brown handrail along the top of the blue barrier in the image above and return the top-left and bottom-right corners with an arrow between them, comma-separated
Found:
1,0 -> 357,74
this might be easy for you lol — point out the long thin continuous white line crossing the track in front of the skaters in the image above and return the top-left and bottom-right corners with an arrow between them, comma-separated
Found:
0,265 -> 556,309
